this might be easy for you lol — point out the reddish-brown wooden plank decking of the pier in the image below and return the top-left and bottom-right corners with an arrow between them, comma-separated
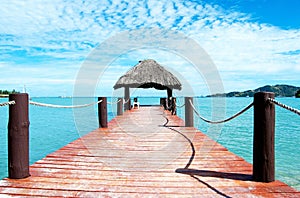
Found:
0,107 -> 300,197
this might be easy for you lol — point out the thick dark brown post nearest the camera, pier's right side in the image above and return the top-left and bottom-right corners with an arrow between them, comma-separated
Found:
253,92 -> 275,182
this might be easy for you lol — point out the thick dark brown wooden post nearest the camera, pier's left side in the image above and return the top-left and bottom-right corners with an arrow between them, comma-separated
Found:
8,93 -> 30,179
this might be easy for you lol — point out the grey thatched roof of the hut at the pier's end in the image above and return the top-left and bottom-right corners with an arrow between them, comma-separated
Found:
114,59 -> 181,90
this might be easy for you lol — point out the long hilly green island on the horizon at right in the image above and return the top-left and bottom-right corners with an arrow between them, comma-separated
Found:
207,85 -> 300,98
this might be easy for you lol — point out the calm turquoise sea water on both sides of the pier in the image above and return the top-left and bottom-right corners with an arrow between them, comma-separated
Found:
0,98 -> 300,190
